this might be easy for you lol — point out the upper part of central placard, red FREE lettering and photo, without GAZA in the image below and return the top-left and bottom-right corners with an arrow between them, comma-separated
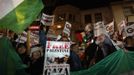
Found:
45,41 -> 70,65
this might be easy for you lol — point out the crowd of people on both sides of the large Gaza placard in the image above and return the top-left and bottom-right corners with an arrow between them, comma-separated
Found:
0,20 -> 134,75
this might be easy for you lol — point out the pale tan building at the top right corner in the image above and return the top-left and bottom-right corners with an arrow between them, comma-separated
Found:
111,0 -> 134,29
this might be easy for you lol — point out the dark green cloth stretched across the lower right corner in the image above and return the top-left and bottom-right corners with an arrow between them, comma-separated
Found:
71,50 -> 134,75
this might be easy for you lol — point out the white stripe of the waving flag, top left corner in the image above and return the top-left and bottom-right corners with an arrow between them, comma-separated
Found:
0,0 -> 24,19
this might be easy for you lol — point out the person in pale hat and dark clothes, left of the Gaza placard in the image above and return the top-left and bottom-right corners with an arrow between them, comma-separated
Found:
29,46 -> 44,75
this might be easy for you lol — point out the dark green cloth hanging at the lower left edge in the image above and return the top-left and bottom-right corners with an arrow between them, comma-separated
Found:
0,37 -> 27,75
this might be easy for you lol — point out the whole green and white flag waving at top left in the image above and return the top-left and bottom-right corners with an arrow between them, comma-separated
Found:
0,0 -> 43,33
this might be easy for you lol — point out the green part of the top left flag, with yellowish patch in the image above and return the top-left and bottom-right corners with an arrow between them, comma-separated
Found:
0,0 -> 43,33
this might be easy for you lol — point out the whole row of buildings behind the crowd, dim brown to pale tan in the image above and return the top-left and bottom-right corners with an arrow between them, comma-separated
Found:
53,0 -> 134,40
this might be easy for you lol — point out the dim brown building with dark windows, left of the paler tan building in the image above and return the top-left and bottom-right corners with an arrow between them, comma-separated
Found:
54,5 -> 113,31
